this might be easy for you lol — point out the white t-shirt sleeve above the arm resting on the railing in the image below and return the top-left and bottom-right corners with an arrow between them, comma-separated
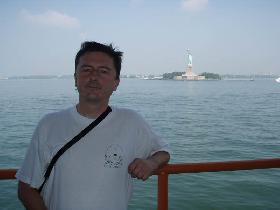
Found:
136,113 -> 170,158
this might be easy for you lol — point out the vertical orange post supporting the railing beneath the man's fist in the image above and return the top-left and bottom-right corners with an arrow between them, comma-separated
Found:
158,172 -> 168,210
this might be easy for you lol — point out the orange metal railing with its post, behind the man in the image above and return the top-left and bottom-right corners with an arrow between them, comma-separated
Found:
0,158 -> 280,210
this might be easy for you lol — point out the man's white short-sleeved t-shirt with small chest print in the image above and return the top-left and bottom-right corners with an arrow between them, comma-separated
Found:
16,107 -> 168,210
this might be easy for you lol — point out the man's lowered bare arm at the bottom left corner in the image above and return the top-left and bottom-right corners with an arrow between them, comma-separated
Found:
18,181 -> 47,210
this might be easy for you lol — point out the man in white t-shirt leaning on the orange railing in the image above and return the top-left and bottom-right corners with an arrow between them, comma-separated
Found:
16,42 -> 170,210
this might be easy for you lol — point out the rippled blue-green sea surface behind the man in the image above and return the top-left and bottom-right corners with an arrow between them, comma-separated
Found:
0,79 -> 280,210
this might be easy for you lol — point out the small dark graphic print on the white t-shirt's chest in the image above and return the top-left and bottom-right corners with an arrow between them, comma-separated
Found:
104,144 -> 123,168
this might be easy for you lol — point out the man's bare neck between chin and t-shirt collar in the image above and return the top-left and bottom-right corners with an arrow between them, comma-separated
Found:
76,102 -> 108,119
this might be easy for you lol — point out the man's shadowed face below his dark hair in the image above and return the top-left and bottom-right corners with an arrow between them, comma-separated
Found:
75,52 -> 120,103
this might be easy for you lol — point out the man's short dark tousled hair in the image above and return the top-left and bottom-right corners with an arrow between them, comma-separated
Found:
75,41 -> 123,79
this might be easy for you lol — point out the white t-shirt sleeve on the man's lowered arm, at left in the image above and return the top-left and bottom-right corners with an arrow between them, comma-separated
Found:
16,122 -> 45,188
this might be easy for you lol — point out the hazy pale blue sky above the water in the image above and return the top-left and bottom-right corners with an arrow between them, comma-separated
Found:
0,0 -> 280,77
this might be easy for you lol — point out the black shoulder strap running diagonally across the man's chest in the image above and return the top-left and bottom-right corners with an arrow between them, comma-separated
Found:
38,106 -> 112,192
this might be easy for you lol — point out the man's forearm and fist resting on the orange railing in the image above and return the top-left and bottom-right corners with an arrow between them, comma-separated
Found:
128,151 -> 170,181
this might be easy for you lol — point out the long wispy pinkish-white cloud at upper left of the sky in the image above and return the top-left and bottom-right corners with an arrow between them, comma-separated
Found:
21,10 -> 80,28
